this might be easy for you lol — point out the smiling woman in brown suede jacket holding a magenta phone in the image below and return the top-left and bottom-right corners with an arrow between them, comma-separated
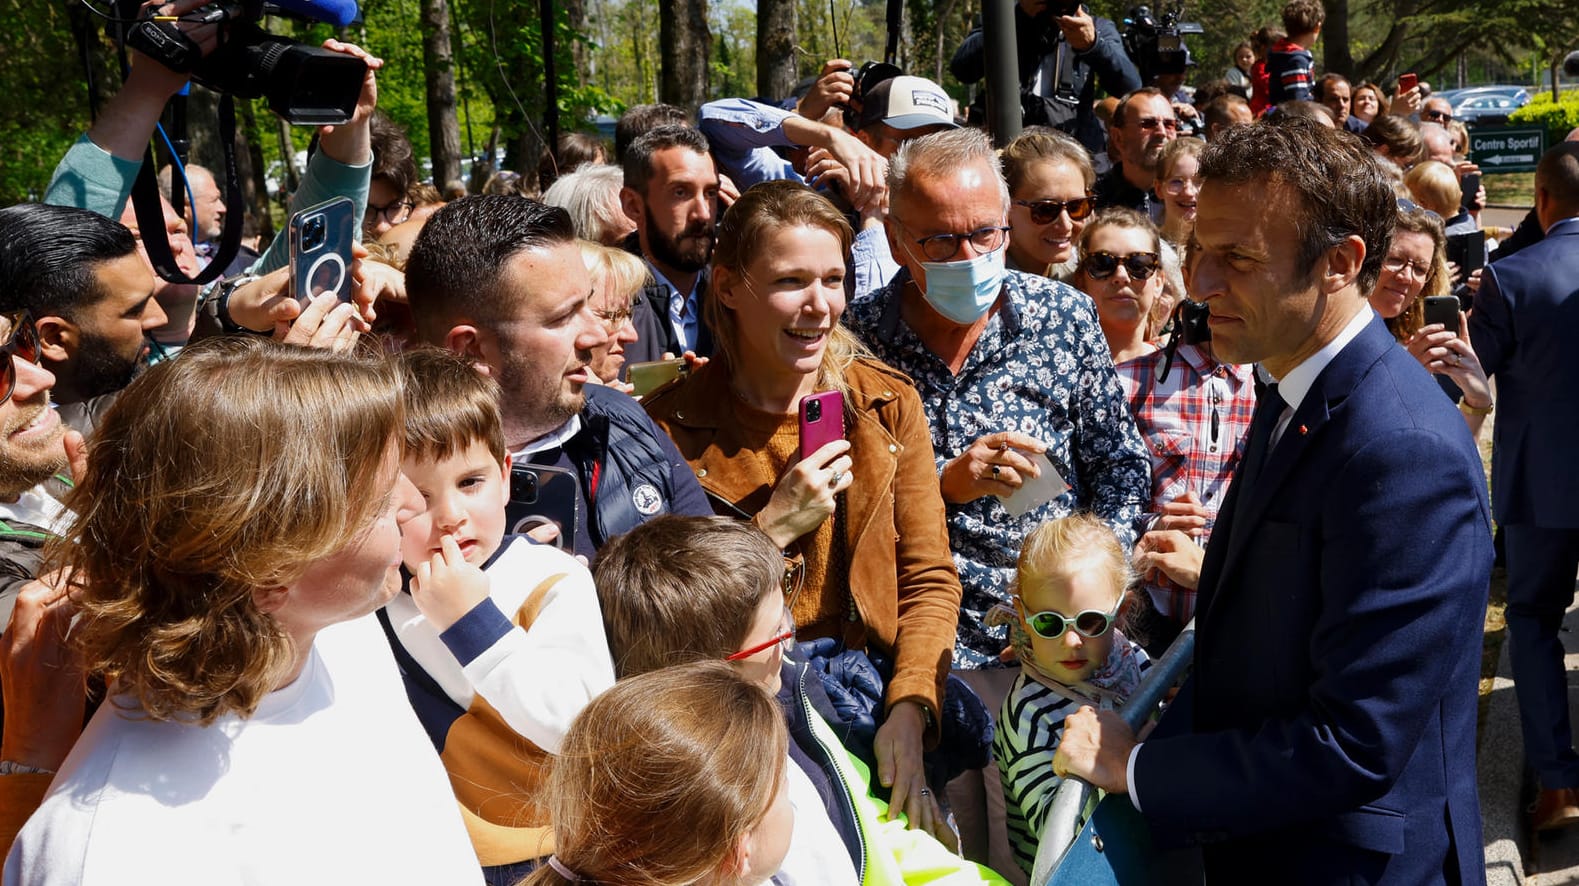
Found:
646,182 -> 960,831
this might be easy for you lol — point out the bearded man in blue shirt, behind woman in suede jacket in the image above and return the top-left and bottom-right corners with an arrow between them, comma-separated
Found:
619,125 -> 718,363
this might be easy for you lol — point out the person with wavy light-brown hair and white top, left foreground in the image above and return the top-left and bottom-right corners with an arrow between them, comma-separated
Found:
6,338 -> 480,884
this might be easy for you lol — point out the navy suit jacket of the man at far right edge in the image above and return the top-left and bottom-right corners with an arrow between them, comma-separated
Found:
1470,218 -> 1579,529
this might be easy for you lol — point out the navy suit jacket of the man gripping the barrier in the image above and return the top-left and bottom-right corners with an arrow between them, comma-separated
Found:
1134,317 -> 1492,884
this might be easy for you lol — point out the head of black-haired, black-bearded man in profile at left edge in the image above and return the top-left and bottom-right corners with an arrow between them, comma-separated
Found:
0,204 -> 166,433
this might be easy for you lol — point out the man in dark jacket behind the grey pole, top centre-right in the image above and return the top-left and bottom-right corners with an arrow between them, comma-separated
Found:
949,0 -> 1140,156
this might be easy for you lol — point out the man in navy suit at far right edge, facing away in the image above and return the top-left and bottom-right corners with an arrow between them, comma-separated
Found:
1470,142 -> 1579,829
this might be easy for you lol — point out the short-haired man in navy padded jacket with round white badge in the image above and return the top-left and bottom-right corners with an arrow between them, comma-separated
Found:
406,197 -> 712,559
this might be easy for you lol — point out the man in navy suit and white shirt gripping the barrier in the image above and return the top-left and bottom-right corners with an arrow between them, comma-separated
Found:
1053,113 -> 1492,884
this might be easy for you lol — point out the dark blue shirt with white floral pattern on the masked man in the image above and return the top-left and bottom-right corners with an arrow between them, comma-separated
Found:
845,270 -> 1151,670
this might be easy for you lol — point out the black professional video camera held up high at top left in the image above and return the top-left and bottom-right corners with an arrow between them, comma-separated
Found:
117,0 -> 368,126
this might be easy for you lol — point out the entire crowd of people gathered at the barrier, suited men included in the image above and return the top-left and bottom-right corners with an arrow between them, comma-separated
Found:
0,0 -> 1579,886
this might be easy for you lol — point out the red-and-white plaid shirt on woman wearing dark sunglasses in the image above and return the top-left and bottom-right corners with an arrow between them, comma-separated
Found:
1116,344 -> 1255,624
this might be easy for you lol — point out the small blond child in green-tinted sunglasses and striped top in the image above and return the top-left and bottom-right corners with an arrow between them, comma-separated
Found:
993,513 -> 1151,873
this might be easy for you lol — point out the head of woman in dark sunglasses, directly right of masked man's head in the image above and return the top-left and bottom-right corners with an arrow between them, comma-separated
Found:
998,126 -> 1096,283
